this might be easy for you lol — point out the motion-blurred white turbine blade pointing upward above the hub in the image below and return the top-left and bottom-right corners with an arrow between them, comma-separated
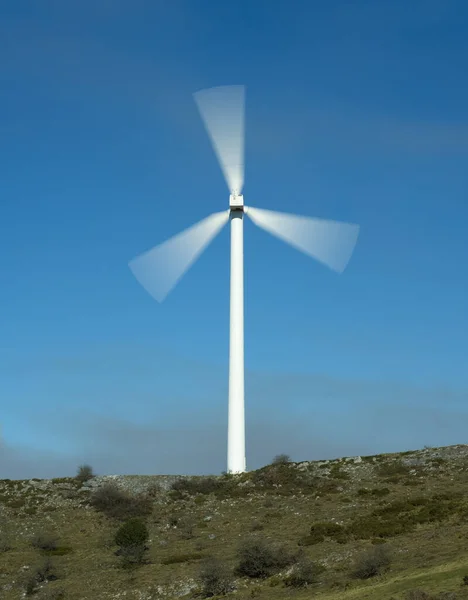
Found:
193,85 -> 245,194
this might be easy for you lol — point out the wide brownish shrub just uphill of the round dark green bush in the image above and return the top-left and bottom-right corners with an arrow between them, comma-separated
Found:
91,483 -> 152,519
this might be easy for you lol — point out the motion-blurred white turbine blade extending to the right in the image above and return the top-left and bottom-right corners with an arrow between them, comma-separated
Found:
246,206 -> 359,273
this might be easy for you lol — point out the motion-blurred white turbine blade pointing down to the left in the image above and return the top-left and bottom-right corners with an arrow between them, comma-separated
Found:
129,211 -> 229,302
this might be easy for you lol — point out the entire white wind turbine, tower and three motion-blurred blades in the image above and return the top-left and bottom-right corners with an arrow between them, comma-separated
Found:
129,86 -> 359,473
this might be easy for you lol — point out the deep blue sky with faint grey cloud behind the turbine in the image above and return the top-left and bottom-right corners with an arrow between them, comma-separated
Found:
0,0 -> 468,477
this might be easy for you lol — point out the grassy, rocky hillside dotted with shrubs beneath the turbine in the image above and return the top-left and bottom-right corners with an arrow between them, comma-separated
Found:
0,446 -> 468,600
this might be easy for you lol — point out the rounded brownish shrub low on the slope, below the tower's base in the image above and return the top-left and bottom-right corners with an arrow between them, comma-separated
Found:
236,537 -> 297,579
